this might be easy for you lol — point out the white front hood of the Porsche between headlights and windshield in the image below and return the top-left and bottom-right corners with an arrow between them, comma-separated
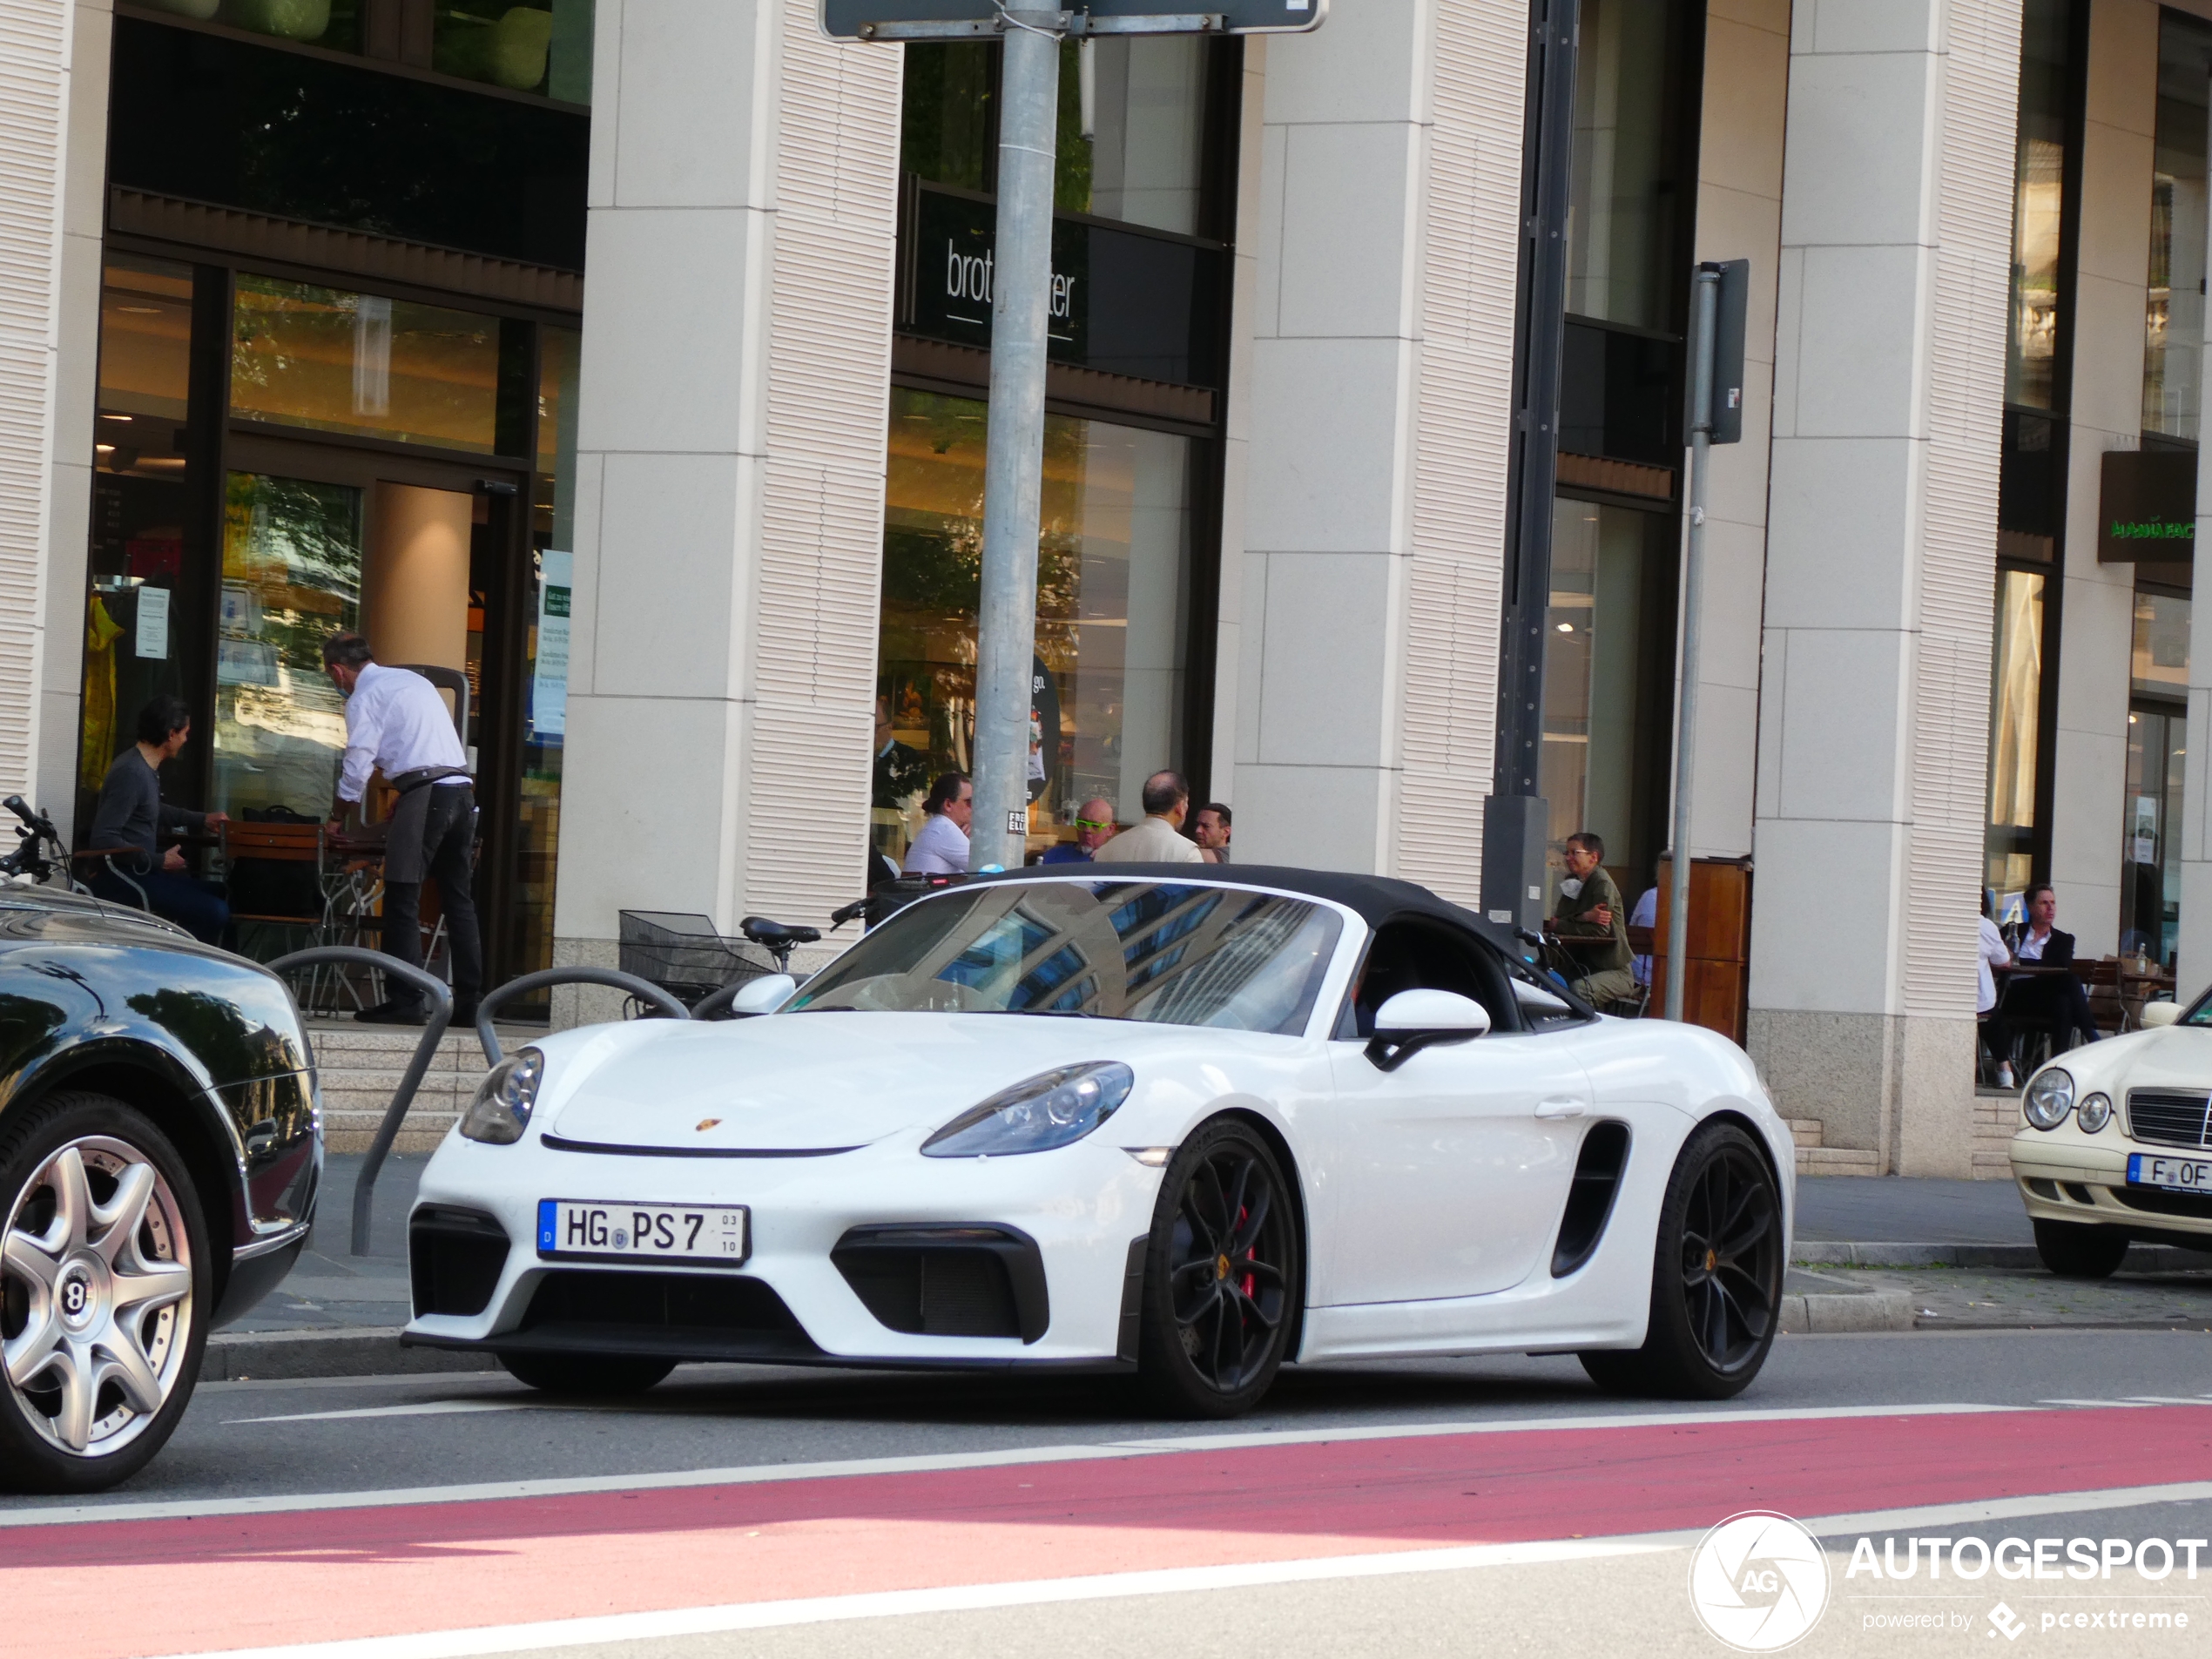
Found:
546,1013 -> 1238,1155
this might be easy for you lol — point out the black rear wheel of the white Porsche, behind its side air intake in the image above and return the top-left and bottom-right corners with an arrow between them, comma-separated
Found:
1581,1123 -> 1785,1400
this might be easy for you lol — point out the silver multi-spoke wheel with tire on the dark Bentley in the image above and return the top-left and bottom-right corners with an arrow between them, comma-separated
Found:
0,1093 -> 214,1494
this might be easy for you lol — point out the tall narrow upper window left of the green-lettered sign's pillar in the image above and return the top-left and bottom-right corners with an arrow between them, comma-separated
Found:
2004,0 -> 2075,409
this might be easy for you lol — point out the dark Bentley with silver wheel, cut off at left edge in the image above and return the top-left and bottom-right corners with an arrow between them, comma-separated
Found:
0,882 -> 323,1491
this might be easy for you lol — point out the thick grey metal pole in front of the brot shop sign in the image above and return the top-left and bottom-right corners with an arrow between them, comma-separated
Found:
969,11 -> 1062,869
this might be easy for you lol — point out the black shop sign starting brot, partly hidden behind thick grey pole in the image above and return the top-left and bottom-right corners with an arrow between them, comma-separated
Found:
898,184 -> 1228,389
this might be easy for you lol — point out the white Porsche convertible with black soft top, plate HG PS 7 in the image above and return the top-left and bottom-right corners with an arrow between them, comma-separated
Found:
407,865 -> 1794,1416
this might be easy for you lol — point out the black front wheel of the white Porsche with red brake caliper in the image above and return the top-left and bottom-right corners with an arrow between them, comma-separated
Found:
1137,1119 -> 1305,1418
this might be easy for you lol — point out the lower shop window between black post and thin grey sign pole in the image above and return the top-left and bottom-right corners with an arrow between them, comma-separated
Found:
1541,500 -> 1675,900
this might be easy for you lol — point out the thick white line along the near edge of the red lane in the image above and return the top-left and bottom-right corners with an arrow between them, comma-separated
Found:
133,1480 -> 2212,1659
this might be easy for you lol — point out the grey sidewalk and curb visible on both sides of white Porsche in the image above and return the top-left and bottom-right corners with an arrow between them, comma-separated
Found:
206,1152 -> 2212,1380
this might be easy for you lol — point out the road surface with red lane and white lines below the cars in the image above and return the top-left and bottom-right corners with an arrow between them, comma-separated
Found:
0,1330 -> 2212,1659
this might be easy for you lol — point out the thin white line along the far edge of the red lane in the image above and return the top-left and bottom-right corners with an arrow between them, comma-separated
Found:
0,1405 -> 2028,1528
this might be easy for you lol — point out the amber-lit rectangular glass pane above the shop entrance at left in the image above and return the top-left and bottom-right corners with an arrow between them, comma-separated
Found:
230,274 -> 516,455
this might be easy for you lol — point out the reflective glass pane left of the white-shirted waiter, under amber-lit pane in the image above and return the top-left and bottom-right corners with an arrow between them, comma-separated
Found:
208,474 -> 363,823
